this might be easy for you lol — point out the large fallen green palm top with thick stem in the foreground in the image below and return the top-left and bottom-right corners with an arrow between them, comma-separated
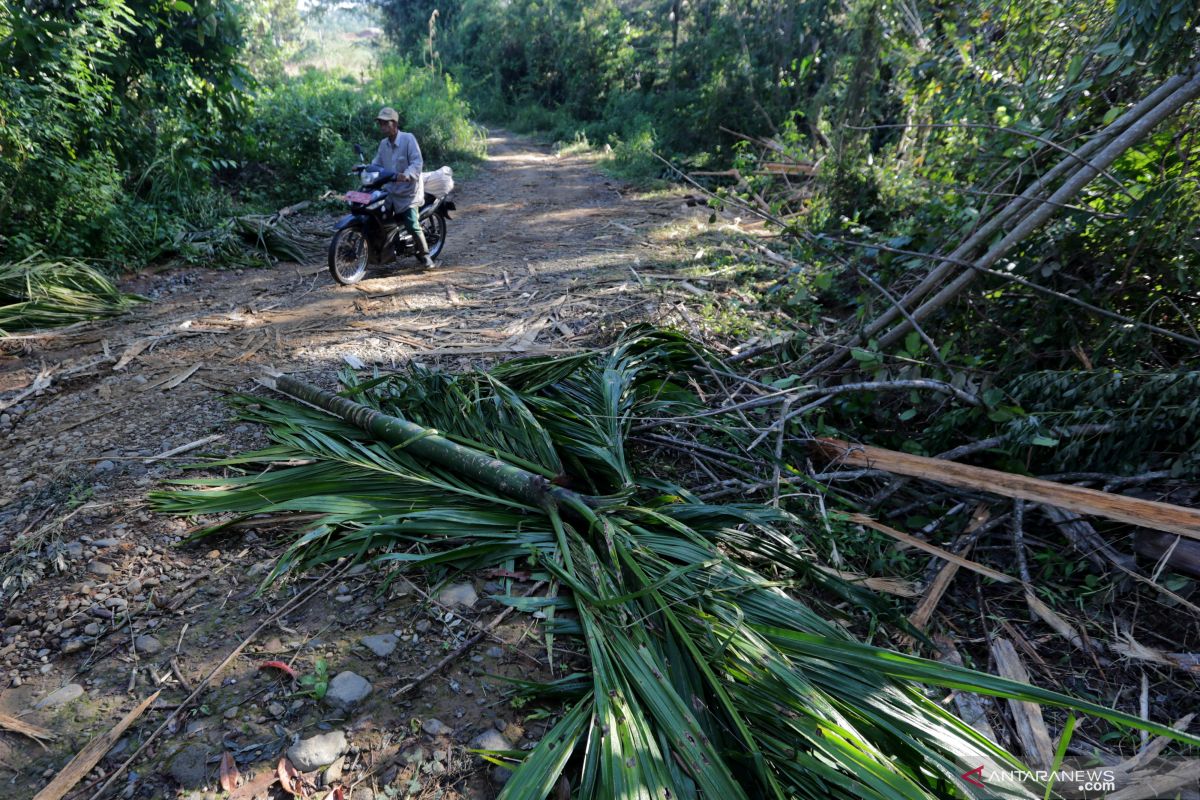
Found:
151,332 -> 1200,800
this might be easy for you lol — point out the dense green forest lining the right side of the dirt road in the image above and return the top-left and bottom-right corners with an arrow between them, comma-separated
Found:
374,0 -> 1200,479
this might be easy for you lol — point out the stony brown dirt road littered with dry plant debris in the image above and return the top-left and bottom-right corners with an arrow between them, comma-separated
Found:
0,132 -> 707,800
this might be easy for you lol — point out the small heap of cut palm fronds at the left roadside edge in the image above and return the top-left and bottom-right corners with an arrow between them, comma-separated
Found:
0,253 -> 145,336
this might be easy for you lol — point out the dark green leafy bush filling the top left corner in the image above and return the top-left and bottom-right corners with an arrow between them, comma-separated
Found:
0,0 -> 250,264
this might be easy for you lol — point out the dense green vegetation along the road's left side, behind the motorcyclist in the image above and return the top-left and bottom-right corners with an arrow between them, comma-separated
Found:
0,0 -> 480,270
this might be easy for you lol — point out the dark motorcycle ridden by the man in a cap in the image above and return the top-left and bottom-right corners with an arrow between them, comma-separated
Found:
329,145 -> 455,285
